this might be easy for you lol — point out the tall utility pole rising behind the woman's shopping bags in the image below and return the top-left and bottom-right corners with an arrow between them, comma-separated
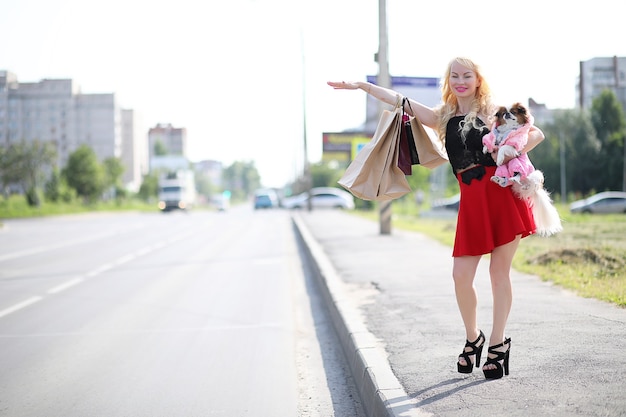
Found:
376,0 -> 391,235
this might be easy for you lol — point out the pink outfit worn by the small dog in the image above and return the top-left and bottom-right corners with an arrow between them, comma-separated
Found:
483,116 -> 535,184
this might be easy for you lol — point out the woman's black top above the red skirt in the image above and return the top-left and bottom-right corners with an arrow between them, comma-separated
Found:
446,116 -> 496,173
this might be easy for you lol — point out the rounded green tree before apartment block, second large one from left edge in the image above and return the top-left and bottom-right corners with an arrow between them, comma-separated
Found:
63,145 -> 105,202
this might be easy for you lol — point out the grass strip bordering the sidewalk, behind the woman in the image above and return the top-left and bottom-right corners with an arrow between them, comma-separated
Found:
355,203 -> 626,307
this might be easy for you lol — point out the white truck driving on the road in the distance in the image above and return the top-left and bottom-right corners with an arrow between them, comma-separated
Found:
159,170 -> 196,211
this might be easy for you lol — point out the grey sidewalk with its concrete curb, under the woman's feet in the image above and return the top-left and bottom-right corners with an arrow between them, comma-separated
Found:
293,210 -> 626,417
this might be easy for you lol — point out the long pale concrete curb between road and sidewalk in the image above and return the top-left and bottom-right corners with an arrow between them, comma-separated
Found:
292,214 -> 430,417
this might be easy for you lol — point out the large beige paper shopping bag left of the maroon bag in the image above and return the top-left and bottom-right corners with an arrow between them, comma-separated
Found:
338,107 -> 411,201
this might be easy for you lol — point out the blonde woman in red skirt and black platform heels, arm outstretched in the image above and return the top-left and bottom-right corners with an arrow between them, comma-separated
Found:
328,58 -> 544,379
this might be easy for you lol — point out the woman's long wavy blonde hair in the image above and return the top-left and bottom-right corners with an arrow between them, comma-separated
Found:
436,57 -> 495,142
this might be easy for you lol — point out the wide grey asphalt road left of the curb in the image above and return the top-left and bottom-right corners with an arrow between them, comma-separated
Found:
0,206 -> 361,417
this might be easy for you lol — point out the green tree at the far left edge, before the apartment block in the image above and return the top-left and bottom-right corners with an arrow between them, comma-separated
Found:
0,140 -> 56,206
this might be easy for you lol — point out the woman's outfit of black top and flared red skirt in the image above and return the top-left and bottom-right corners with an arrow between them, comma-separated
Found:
446,116 -> 536,257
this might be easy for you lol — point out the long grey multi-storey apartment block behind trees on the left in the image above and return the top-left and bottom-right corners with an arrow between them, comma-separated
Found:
0,70 -> 147,188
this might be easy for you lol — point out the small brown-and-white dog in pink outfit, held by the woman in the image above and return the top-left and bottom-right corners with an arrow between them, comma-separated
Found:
483,103 -> 563,236
